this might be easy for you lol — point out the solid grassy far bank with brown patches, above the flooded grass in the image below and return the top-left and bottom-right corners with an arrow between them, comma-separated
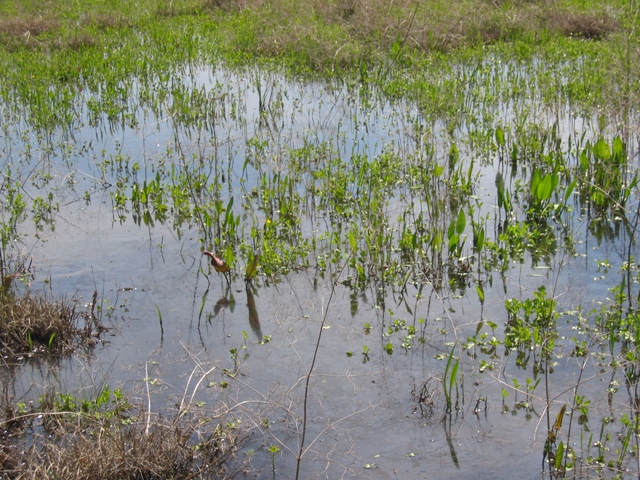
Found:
0,0 -> 638,87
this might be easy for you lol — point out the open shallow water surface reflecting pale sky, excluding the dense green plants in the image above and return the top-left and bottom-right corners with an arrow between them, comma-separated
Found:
5,62 -> 635,479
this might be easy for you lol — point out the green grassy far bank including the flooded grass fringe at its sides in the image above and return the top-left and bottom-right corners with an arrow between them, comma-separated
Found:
0,0 -> 640,143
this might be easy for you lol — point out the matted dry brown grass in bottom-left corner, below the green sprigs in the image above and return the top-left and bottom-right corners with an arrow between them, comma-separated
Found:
0,406 -> 244,480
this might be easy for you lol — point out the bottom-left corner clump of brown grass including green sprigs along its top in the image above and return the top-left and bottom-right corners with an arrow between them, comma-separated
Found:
0,386 -> 245,480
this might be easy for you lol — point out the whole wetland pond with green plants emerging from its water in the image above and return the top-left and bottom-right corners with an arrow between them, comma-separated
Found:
2,62 -> 640,479
